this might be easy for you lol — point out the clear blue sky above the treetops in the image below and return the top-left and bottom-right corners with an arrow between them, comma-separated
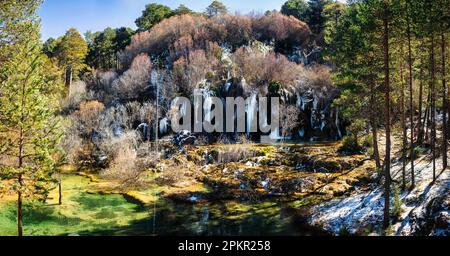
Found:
39,0 -> 286,40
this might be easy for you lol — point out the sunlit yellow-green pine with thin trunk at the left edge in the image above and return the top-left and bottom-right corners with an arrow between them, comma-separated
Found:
0,1 -> 61,236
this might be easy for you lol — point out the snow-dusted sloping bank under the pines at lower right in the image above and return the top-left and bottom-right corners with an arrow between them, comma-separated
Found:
308,150 -> 450,236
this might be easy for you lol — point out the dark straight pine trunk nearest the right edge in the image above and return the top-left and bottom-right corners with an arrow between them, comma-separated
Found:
441,33 -> 448,170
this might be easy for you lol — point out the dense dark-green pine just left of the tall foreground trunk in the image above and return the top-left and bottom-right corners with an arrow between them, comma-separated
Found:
328,3 -> 383,169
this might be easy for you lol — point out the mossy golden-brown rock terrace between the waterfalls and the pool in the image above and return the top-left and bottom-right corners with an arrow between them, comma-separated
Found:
187,144 -> 374,201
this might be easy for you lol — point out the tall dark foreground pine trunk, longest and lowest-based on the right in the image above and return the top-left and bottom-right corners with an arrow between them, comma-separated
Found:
383,3 -> 391,229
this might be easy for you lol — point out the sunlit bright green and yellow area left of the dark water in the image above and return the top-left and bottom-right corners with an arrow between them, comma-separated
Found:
0,175 -> 148,236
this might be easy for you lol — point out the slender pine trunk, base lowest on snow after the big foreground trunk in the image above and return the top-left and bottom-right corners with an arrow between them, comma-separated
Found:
406,1 -> 414,188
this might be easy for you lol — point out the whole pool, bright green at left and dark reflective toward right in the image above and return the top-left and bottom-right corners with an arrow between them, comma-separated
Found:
0,175 -> 312,236
